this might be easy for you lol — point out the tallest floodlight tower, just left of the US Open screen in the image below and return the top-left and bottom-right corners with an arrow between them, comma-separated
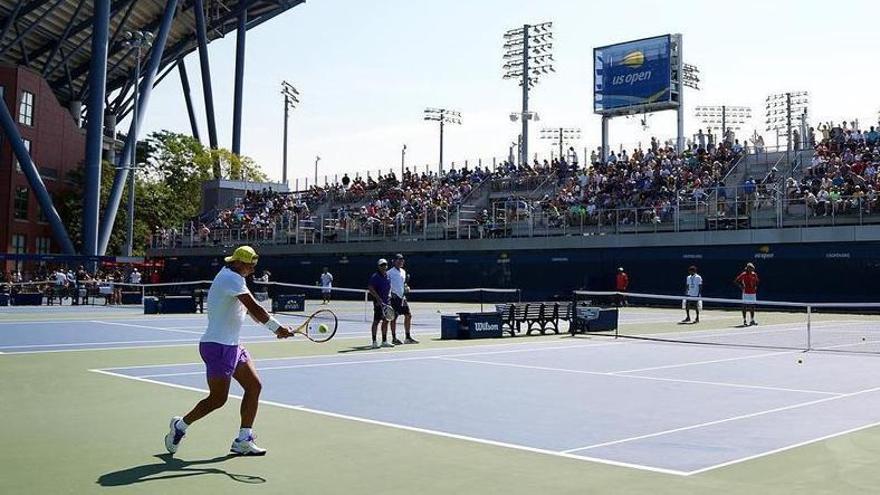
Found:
502,22 -> 556,167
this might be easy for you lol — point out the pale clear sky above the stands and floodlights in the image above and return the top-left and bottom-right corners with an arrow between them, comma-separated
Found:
144,0 -> 880,185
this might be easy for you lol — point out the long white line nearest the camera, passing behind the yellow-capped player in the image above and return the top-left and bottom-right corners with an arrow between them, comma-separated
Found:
89,369 -> 687,476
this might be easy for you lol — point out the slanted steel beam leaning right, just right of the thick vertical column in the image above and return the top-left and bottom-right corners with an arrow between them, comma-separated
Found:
98,0 -> 177,255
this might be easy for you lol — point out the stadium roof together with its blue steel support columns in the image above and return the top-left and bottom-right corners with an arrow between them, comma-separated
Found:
0,0 -> 305,256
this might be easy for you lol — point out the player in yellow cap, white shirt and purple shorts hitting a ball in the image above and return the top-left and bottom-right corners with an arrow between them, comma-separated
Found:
165,246 -> 293,455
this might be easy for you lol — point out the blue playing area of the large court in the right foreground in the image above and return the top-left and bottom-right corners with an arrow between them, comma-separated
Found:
94,337 -> 880,475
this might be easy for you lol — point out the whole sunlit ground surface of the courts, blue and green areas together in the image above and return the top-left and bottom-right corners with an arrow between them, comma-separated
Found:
0,301 -> 880,493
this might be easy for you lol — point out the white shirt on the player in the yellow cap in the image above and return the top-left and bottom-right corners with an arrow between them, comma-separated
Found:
201,267 -> 250,345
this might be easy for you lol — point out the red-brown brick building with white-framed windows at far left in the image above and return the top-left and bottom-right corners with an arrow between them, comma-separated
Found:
0,65 -> 86,269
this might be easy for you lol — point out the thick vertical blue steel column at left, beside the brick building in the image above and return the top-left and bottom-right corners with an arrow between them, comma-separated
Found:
83,0 -> 110,256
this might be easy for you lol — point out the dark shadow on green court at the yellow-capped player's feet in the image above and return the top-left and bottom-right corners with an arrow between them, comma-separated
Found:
97,454 -> 266,486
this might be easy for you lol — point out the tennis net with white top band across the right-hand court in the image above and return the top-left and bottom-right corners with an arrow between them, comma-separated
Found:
573,291 -> 880,354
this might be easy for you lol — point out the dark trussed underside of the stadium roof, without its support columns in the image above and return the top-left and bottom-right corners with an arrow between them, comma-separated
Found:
0,0 -> 305,112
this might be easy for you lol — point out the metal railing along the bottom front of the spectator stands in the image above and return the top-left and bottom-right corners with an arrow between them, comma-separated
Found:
151,192 -> 880,249
